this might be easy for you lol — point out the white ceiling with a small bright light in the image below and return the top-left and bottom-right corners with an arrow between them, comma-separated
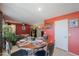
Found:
0,3 -> 79,24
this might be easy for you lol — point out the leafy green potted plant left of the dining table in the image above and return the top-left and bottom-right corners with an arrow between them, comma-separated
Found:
3,24 -> 17,45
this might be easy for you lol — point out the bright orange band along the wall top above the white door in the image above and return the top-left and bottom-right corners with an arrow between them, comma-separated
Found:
44,11 -> 79,24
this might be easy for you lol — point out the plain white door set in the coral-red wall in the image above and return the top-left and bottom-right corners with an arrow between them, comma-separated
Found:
55,20 -> 68,51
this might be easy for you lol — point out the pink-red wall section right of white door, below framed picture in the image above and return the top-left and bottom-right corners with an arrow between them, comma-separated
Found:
68,28 -> 79,55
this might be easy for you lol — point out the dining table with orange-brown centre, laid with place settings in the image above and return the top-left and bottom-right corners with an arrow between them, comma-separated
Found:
17,37 -> 47,55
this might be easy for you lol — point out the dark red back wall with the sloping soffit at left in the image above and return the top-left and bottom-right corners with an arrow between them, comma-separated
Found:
4,15 -> 30,35
